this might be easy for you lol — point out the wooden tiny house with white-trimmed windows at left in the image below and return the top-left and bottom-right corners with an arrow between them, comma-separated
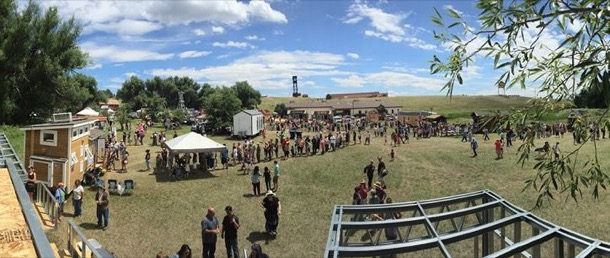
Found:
21,113 -> 97,189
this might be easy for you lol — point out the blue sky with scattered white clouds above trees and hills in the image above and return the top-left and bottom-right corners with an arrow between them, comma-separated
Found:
39,0 -> 540,96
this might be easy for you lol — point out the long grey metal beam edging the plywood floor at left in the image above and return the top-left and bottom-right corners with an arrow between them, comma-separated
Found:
4,159 -> 55,257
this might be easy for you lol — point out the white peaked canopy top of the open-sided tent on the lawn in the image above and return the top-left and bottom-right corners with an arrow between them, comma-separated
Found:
163,132 -> 226,153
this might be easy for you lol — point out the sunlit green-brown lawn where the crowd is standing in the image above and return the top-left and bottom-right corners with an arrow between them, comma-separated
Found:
39,123 -> 610,257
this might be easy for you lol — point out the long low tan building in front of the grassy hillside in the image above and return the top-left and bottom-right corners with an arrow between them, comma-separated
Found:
286,100 -> 402,118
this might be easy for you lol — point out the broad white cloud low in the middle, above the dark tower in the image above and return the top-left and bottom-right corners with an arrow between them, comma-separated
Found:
147,51 -> 348,89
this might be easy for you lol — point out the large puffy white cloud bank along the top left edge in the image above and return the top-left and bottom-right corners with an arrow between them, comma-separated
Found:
37,0 -> 288,38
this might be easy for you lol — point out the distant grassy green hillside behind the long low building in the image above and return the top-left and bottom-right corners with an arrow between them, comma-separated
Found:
260,96 -> 531,120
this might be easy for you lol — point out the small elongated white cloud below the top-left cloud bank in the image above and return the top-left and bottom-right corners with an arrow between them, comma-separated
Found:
80,42 -> 174,62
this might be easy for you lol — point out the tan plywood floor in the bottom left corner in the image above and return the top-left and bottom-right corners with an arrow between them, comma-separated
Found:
0,168 -> 36,257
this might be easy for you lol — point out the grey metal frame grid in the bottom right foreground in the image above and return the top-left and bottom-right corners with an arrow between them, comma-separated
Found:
324,190 -> 610,258
